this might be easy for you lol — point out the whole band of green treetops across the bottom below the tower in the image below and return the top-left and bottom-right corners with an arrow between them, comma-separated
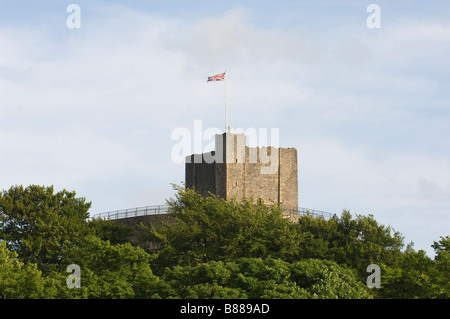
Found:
0,185 -> 450,299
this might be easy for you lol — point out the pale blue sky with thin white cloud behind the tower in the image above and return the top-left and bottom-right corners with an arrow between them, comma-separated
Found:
0,0 -> 450,257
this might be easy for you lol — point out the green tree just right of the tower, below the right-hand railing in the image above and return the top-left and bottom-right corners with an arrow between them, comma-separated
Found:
298,211 -> 403,279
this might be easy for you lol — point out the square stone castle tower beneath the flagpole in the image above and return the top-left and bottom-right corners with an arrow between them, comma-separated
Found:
185,133 -> 298,210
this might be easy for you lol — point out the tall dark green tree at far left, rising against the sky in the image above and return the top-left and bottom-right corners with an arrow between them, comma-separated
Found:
0,185 -> 91,270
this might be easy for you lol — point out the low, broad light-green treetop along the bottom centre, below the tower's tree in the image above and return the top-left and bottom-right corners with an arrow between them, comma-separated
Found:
149,258 -> 370,299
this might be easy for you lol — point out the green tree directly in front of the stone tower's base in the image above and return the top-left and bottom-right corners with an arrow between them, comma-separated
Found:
144,188 -> 299,267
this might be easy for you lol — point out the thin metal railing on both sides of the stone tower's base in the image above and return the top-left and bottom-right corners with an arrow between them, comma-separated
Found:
92,205 -> 333,220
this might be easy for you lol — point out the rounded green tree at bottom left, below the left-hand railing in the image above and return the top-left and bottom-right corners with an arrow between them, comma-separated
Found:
49,236 -> 158,299
